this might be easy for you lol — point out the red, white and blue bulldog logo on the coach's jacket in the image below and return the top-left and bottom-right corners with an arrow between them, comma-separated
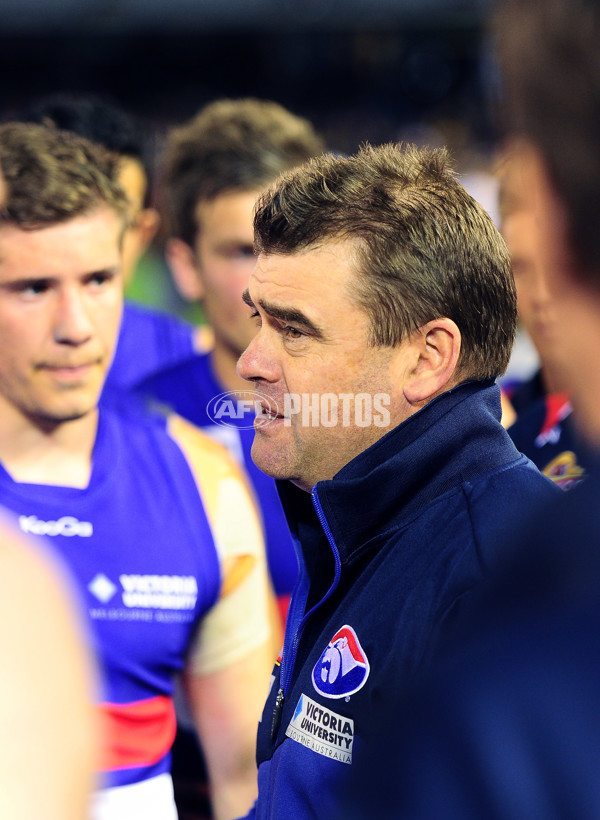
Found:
312,624 -> 370,698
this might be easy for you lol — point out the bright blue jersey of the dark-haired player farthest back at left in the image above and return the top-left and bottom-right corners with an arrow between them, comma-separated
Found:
105,302 -> 196,391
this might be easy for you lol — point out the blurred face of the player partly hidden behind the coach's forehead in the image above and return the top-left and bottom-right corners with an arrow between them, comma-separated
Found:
195,191 -> 260,358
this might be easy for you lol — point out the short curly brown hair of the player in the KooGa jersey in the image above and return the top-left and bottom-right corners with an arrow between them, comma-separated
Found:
0,122 -> 127,230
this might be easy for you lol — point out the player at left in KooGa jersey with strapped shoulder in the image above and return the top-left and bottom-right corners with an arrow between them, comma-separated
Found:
0,123 -> 272,820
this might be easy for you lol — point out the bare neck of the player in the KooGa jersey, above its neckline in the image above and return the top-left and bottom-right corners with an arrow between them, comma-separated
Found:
0,410 -> 98,488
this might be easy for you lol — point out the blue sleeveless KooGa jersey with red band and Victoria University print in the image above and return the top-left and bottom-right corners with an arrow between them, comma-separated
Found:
0,410 -> 221,787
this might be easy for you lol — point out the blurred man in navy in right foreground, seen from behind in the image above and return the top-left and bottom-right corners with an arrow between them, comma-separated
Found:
338,0 -> 600,820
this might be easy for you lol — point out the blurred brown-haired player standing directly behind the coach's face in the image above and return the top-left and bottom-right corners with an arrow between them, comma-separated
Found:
141,98 -> 323,618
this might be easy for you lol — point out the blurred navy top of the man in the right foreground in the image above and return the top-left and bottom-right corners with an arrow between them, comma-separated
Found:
340,453 -> 600,820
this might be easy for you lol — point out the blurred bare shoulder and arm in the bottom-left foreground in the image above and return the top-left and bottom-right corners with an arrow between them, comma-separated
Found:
0,521 -> 97,820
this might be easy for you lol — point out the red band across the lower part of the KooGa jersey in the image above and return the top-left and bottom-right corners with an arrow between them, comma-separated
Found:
98,697 -> 177,772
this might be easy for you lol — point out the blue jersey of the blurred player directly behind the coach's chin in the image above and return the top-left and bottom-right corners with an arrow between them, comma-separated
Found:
139,348 -> 298,615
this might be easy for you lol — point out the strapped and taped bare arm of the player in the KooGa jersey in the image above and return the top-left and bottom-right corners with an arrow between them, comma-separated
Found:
170,419 -> 281,820
